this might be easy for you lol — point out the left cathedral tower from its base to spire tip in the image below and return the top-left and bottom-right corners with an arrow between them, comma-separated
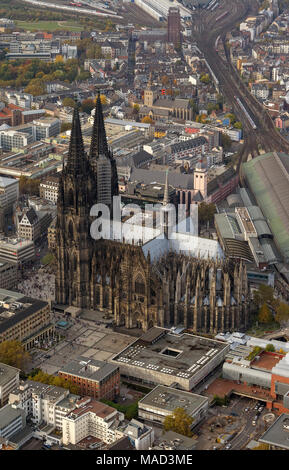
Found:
55,106 -> 96,307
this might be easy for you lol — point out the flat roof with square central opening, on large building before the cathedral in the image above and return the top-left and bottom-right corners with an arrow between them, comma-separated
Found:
112,327 -> 228,379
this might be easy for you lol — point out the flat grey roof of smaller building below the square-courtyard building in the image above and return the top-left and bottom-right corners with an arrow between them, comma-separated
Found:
139,385 -> 208,414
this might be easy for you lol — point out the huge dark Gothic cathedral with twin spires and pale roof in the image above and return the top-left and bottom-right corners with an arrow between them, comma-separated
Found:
55,94 -> 249,334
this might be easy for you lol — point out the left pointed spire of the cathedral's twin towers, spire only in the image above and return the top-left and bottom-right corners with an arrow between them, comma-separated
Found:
67,103 -> 84,172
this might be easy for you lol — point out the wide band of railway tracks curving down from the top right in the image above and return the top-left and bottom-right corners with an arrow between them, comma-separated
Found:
193,0 -> 289,174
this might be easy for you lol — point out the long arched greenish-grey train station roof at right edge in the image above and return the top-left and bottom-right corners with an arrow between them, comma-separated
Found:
244,152 -> 289,262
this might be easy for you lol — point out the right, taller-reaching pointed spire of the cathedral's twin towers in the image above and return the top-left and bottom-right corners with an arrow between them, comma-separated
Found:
89,90 -> 109,158
